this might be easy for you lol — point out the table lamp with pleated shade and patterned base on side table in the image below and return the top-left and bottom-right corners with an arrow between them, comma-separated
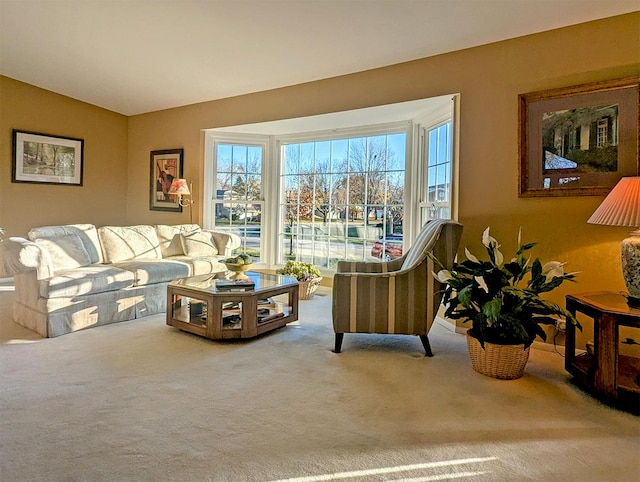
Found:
587,176 -> 640,308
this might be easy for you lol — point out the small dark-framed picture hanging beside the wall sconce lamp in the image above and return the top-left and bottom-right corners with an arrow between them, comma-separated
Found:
149,149 -> 183,213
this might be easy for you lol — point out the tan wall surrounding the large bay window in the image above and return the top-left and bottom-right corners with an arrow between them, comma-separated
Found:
128,13 -> 640,302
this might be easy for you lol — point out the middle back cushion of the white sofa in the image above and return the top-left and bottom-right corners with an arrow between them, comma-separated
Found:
98,225 -> 162,263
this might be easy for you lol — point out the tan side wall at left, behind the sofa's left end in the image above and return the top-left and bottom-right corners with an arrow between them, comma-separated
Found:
0,77 -> 128,236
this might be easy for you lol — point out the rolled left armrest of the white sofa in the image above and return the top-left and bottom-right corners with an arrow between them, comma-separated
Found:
0,237 -> 53,279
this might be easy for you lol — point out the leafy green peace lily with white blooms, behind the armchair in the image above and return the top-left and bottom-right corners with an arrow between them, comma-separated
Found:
434,228 -> 582,349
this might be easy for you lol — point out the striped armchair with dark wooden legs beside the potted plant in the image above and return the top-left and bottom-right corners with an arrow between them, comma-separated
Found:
333,219 -> 462,356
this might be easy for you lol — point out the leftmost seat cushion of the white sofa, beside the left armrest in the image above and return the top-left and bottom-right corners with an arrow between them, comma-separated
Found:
38,264 -> 134,298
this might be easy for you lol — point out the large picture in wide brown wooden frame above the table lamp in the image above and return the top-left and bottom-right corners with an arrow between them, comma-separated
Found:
519,77 -> 640,197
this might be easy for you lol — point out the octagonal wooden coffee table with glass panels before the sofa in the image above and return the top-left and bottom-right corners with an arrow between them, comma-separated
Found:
167,271 -> 298,340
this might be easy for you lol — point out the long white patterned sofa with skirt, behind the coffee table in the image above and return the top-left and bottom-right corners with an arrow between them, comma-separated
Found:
0,224 -> 240,337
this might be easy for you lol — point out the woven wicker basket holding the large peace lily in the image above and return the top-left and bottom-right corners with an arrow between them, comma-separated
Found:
467,330 -> 531,380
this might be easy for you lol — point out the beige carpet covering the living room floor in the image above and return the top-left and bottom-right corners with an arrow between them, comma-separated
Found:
0,284 -> 640,482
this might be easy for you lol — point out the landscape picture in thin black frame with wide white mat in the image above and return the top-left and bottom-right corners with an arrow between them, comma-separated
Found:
11,129 -> 84,186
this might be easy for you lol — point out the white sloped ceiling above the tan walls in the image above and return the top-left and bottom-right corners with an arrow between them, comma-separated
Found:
0,0 -> 640,115
